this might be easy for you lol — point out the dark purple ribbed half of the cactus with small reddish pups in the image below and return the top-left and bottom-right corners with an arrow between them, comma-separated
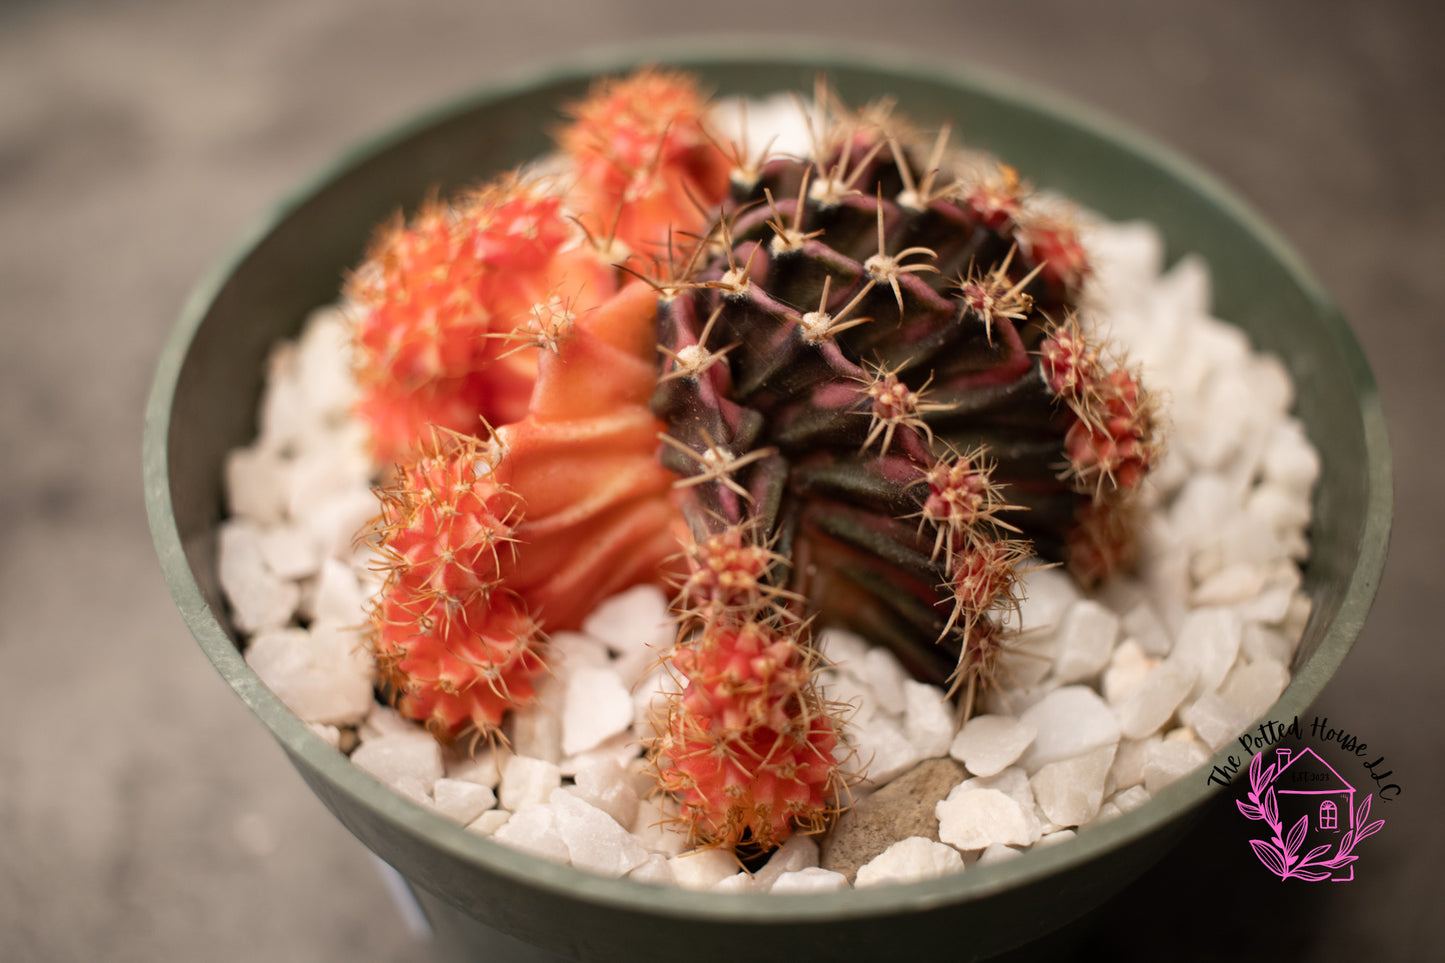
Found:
653,99 -> 1155,700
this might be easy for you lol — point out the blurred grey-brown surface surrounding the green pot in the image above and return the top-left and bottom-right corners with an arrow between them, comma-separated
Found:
0,0 -> 1445,962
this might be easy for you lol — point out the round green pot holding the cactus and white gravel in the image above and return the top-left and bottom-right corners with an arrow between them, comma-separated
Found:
145,42 -> 1392,963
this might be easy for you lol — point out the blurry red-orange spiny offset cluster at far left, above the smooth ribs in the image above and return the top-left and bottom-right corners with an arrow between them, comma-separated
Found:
355,175 -> 616,463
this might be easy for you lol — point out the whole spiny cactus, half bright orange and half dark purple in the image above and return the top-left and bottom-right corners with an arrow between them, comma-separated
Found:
350,71 -> 1159,850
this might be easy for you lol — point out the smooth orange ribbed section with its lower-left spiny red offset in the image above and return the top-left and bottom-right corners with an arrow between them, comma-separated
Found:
373,282 -> 676,739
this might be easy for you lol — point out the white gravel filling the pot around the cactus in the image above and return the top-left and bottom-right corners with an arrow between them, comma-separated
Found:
220,104 -> 1319,892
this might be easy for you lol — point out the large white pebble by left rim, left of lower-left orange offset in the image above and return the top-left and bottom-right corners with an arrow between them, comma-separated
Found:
246,623 -> 376,726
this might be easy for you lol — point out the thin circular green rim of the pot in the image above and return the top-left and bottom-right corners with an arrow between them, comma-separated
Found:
143,35 -> 1393,923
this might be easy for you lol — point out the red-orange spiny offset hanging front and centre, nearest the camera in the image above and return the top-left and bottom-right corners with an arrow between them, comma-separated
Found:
652,514 -> 845,852
